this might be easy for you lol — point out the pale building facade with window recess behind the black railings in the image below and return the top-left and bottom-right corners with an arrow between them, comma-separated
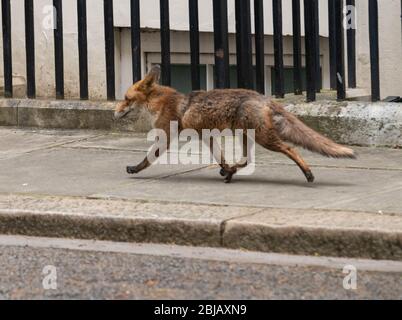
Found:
0,0 -> 402,100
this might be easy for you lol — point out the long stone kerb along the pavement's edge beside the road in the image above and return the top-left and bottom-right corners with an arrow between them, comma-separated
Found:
0,195 -> 402,260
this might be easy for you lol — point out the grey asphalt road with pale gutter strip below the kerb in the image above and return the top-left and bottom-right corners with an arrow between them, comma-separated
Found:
0,236 -> 402,299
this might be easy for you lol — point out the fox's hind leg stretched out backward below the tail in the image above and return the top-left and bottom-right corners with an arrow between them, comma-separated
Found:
257,134 -> 314,182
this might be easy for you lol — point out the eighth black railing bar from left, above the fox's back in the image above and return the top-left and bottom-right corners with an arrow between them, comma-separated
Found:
188,0 -> 201,91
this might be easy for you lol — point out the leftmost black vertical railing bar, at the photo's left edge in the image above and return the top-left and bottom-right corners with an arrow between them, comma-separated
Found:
1,0 -> 13,98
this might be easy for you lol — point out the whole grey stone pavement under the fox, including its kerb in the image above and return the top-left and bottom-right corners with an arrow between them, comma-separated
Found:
0,127 -> 402,260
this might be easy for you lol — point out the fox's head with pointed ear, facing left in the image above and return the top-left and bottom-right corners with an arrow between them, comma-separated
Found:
114,65 -> 161,120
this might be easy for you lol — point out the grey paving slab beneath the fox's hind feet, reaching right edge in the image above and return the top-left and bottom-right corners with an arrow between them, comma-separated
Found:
97,164 -> 402,214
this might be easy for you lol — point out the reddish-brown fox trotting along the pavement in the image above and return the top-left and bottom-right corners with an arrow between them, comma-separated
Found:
114,65 -> 356,183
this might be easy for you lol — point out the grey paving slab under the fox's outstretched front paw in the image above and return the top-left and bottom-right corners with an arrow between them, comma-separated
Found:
0,148 -> 207,196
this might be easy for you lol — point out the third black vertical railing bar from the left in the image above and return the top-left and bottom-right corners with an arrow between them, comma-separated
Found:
53,0 -> 64,99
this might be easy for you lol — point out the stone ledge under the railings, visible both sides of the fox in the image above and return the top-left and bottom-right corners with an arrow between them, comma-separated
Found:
0,99 -> 402,147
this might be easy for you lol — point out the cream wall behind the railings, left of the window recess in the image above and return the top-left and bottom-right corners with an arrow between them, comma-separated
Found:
0,0 -> 106,99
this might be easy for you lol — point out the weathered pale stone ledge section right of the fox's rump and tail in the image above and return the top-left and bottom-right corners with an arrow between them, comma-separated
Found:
287,101 -> 402,147
